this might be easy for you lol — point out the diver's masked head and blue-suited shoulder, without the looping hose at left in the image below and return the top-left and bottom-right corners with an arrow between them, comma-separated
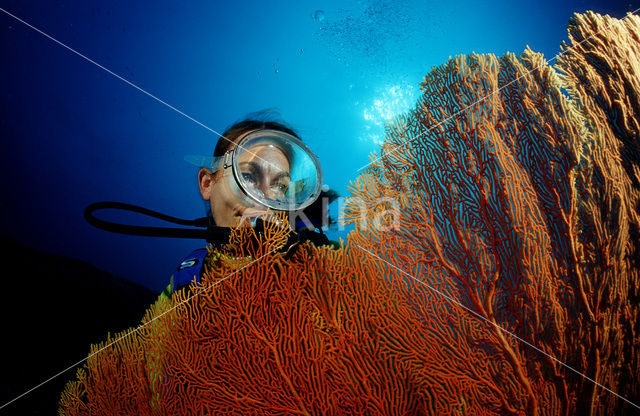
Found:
163,120 -> 337,295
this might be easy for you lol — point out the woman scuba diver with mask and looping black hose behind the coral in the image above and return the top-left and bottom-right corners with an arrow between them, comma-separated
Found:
85,119 -> 338,296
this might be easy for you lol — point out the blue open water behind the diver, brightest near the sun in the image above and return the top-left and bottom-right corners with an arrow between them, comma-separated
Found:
0,0 -> 638,292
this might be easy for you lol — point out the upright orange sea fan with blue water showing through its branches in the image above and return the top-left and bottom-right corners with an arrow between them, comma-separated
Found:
346,51 -> 577,414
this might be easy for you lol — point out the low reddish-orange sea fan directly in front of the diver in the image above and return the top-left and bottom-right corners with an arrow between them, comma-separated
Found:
61,216 -> 456,414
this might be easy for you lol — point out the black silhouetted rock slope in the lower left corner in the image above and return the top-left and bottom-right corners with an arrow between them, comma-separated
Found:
0,236 -> 158,416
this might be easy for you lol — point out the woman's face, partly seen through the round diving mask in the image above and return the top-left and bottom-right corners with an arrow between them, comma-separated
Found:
198,132 -> 290,227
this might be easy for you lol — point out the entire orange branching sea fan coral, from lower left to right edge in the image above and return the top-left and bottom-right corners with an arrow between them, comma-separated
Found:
59,13 -> 640,415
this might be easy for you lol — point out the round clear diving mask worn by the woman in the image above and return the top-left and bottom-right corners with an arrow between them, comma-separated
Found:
211,130 -> 322,211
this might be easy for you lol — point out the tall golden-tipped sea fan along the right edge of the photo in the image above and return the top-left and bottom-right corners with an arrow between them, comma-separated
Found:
558,13 -> 640,412
